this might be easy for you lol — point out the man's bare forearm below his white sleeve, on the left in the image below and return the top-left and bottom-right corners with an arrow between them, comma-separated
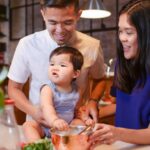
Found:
8,79 -> 45,124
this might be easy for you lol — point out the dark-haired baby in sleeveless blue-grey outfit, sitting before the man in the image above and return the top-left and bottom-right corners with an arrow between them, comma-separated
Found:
23,46 -> 93,142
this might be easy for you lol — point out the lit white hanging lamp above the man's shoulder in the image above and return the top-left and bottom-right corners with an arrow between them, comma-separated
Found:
81,0 -> 111,19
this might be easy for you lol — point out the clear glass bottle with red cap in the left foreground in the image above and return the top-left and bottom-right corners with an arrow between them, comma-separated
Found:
0,99 -> 21,150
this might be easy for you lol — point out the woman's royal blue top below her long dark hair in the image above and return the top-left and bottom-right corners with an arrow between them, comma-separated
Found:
116,76 -> 150,129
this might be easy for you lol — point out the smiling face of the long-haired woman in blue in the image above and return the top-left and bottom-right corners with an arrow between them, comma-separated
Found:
118,13 -> 138,59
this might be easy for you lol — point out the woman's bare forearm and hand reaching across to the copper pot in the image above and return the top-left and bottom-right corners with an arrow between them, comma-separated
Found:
90,124 -> 150,145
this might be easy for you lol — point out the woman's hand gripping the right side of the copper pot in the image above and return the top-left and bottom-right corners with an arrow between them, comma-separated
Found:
89,123 -> 117,147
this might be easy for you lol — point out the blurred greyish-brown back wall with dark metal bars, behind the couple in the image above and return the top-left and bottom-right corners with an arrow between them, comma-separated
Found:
0,0 -> 129,65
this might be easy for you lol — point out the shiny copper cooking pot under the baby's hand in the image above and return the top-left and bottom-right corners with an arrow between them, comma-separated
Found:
51,125 -> 92,150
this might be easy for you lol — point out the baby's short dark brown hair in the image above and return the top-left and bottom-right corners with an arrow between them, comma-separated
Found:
49,46 -> 84,70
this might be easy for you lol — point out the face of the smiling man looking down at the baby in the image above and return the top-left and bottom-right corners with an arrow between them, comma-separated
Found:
41,6 -> 80,45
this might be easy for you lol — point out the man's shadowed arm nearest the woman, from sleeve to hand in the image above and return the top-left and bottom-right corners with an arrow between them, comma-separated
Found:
87,40 -> 106,122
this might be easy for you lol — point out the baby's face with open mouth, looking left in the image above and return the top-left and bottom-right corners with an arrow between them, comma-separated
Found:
48,54 -> 75,85
